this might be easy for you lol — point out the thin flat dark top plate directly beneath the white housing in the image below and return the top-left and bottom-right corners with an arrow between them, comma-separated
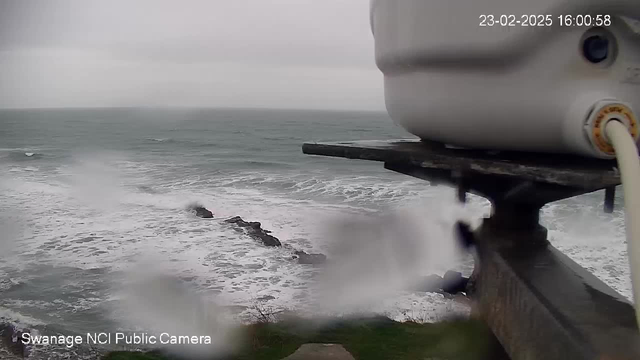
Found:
302,140 -> 620,188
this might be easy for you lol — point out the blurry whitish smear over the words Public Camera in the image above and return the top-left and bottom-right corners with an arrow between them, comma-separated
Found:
114,262 -> 237,359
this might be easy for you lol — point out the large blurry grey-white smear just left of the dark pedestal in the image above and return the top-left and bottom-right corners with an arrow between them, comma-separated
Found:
315,199 -> 463,312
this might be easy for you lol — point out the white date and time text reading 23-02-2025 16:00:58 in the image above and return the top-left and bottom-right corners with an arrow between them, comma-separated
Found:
479,14 -> 612,27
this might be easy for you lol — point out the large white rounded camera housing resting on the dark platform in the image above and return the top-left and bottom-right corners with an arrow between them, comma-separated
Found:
371,0 -> 640,158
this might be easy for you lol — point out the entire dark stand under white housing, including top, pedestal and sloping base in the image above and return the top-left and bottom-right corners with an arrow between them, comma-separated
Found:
303,140 -> 640,360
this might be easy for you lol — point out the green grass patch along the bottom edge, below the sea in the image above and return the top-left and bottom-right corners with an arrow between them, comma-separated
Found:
105,318 -> 494,360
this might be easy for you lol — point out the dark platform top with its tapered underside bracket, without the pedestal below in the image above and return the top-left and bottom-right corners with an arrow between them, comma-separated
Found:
302,140 -> 620,207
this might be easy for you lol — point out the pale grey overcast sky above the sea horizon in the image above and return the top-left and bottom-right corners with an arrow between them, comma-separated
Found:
0,0 -> 384,110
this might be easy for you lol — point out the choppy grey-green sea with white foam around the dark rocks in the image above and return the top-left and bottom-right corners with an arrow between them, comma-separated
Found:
0,109 -> 631,358
